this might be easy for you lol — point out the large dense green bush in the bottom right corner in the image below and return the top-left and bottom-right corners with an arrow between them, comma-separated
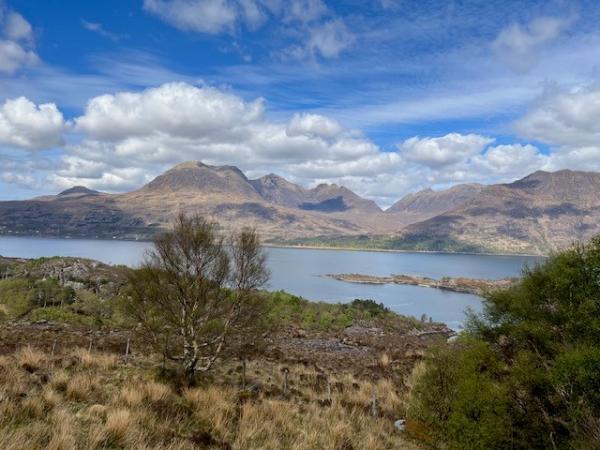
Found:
409,238 -> 600,449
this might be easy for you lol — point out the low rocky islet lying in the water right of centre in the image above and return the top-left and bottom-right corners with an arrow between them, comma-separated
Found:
327,273 -> 517,295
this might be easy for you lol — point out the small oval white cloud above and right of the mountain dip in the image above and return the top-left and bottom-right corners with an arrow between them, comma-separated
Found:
399,133 -> 493,168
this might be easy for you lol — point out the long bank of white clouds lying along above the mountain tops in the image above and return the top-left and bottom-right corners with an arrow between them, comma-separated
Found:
0,82 -> 600,206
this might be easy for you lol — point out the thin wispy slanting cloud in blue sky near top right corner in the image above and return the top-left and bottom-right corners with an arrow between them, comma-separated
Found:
492,17 -> 573,72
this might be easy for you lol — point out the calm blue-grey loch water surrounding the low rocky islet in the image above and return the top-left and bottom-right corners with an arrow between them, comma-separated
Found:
0,236 -> 540,328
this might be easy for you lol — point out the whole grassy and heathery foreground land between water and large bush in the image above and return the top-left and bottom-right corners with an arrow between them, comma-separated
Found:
0,258 -> 448,450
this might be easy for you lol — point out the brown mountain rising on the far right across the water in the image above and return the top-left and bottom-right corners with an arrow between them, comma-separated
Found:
400,170 -> 600,254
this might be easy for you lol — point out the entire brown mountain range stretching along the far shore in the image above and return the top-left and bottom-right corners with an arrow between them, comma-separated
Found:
0,162 -> 600,254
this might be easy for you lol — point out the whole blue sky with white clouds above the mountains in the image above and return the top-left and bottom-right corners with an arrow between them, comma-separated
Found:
0,0 -> 600,207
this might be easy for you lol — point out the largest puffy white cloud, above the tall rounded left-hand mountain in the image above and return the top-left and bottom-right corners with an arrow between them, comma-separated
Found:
54,83 -> 379,189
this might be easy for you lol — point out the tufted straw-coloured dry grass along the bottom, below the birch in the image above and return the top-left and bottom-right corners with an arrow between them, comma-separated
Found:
0,348 -> 416,450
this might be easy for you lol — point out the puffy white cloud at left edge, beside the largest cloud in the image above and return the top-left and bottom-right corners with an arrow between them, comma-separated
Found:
0,97 -> 65,150
